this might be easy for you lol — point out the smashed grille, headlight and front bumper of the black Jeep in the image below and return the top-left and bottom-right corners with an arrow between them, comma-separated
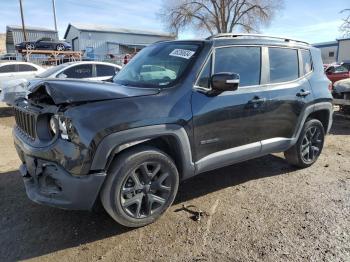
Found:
13,81 -> 106,210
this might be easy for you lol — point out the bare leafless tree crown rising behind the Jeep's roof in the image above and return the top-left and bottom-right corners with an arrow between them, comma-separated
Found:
161,0 -> 283,35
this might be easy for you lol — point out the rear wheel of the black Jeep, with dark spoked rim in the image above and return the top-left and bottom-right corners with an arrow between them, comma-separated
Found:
284,119 -> 325,168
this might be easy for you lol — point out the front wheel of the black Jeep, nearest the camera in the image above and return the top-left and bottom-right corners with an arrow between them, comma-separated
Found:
100,146 -> 179,227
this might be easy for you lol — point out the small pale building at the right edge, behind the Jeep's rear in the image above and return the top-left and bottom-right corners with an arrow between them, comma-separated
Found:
313,38 -> 350,64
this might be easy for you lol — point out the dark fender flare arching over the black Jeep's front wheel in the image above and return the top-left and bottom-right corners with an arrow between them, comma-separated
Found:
90,124 -> 195,179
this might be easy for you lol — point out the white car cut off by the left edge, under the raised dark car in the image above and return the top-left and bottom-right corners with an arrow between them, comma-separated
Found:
0,61 -> 45,91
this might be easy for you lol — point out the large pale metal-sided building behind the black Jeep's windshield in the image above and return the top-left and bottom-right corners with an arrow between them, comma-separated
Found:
64,23 -> 175,59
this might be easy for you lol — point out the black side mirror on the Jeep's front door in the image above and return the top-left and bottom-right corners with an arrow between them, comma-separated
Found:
210,73 -> 239,93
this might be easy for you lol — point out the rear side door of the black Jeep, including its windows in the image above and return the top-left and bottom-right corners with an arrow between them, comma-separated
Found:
262,47 -> 312,145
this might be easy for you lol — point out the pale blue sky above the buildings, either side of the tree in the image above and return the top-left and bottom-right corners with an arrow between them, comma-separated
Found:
0,0 -> 350,43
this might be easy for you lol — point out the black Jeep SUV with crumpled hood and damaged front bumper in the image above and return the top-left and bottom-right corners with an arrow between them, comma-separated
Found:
13,34 -> 332,227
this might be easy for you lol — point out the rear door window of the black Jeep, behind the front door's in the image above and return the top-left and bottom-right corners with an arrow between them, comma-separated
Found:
269,47 -> 299,83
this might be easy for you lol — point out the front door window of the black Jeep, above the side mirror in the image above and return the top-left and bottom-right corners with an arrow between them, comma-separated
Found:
214,47 -> 261,87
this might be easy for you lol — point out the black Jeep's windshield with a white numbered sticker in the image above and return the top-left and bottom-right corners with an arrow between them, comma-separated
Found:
113,43 -> 199,88
